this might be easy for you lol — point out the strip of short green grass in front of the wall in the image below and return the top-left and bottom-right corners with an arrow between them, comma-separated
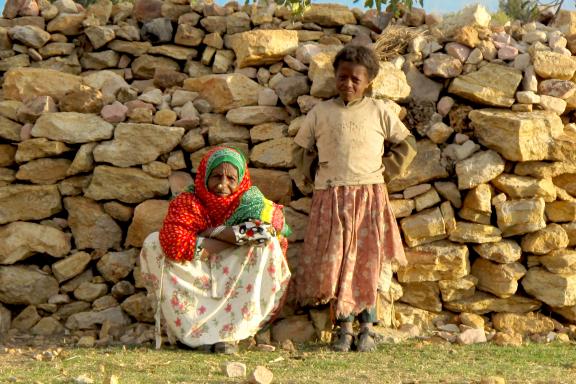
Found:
0,342 -> 576,384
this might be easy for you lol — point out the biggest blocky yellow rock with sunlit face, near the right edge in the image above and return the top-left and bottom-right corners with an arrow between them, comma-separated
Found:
469,109 -> 564,161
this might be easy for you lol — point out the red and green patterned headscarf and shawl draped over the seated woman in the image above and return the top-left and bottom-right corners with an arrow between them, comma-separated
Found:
160,147 -> 288,261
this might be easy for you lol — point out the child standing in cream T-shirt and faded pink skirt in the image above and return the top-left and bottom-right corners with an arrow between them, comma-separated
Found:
294,45 -> 416,352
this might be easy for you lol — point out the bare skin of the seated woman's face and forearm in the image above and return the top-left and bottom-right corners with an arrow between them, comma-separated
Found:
200,163 -> 240,253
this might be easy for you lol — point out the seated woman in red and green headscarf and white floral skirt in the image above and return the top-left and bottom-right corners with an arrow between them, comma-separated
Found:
140,147 -> 290,353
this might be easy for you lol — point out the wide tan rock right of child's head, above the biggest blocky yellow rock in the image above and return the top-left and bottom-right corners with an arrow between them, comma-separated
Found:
448,64 -> 522,107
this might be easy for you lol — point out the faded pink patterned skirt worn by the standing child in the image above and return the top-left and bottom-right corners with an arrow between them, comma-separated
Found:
294,184 -> 406,318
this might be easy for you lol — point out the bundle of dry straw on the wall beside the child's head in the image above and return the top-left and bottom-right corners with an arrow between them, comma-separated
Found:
373,24 -> 427,61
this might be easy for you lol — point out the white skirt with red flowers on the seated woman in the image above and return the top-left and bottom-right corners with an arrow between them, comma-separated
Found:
140,232 -> 290,347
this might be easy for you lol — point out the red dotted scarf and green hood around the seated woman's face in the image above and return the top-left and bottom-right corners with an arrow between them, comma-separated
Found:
160,147 -> 252,261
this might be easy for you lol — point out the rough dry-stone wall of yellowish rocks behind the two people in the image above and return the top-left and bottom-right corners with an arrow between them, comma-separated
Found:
0,0 -> 576,345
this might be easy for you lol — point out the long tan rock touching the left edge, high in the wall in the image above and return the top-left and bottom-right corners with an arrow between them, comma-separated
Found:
3,68 -> 82,101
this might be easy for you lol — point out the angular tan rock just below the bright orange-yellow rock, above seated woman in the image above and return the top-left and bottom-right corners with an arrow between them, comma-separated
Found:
184,73 -> 264,113
